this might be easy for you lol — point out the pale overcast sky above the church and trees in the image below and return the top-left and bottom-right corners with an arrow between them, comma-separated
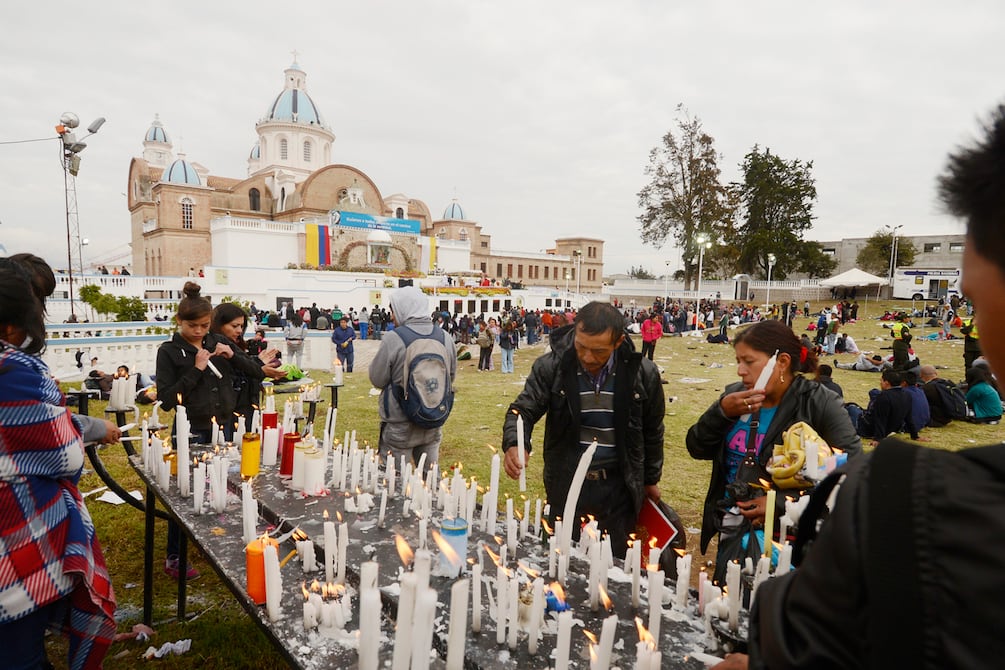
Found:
0,0 -> 1005,274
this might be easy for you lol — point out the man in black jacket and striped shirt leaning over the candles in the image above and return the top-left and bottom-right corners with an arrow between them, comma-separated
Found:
503,302 -> 665,557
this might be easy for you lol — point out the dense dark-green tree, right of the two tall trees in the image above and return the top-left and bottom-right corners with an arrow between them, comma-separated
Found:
733,145 -> 816,279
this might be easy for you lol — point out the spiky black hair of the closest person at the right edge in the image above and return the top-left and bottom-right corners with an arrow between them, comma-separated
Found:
939,104 -> 1005,272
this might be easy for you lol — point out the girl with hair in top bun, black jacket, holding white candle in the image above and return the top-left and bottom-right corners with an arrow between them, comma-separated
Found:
157,281 -> 260,579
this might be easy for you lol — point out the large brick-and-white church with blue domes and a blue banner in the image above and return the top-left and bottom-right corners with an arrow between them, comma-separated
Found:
128,61 -> 604,292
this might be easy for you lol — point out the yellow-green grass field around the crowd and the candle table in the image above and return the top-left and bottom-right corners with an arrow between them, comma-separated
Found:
49,302 -> 1005,669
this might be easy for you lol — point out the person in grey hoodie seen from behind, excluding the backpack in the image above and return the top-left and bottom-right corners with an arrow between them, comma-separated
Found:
369,286 -> 457,467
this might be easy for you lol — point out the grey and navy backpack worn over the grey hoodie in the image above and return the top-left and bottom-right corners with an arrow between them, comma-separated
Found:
391,325 -> 453,428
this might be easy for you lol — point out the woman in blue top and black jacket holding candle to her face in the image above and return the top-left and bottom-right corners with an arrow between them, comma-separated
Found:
686,320 -> 862,582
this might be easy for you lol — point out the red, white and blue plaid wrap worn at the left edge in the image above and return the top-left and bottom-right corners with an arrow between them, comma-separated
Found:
0,342 -> 116,669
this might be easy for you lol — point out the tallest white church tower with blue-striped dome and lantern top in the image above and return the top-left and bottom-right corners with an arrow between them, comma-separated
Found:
248,60 -> 335,183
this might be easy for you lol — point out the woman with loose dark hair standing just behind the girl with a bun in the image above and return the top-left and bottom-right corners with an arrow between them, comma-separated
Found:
209,302 -> 285,432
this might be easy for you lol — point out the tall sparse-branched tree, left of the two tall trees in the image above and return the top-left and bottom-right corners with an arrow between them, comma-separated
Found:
638,104 -> 733,285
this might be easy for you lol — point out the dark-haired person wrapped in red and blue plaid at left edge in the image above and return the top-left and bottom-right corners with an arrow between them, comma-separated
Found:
0,259 -> 116,668
